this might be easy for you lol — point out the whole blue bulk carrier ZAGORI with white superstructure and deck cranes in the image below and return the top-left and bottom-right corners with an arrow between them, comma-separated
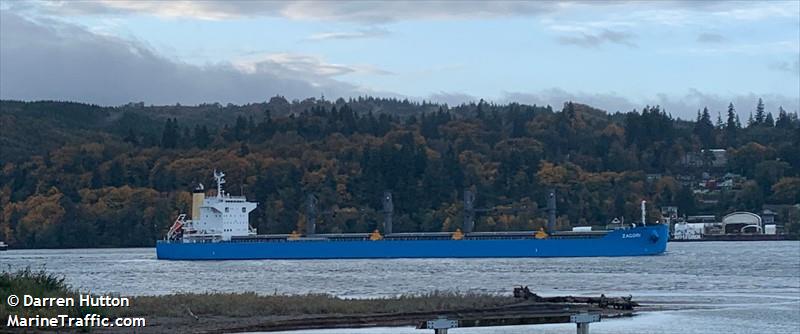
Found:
156,171 -> 669,260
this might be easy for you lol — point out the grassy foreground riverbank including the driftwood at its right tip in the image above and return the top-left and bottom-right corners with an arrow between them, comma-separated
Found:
0,269 -> 648,333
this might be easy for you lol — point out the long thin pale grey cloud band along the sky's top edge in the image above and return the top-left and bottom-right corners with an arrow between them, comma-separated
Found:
26,0 -> 563,23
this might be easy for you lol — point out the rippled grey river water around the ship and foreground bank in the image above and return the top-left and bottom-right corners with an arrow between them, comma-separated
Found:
0,241 -> 800,334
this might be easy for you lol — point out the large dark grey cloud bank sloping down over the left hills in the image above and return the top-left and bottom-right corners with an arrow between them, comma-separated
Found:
0,10 -> 363,105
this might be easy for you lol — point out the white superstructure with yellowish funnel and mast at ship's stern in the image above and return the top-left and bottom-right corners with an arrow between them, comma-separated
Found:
167,171 -> 257,242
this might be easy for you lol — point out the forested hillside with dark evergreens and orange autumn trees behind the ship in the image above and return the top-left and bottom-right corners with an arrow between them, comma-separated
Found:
0,97 -> 800,247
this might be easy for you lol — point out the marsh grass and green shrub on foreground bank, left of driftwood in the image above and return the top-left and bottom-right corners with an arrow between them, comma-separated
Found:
0,268 -> 513,319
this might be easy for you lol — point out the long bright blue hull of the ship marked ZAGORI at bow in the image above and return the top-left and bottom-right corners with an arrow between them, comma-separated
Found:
156,225 -> 669,260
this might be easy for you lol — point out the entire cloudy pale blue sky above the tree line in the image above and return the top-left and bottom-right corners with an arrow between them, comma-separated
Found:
0,0 -> 800,118
